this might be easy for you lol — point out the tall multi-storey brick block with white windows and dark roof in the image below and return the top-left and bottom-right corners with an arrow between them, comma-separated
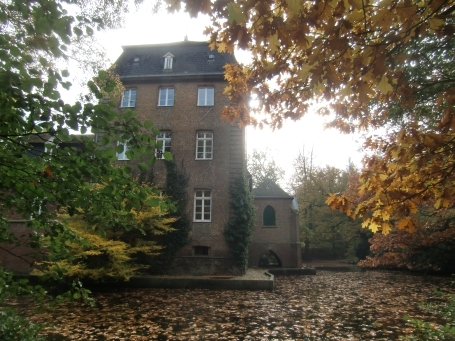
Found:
116,41 -> 245,274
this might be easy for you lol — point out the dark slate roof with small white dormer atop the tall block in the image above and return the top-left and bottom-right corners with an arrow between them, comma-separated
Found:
115,41 -> 237,80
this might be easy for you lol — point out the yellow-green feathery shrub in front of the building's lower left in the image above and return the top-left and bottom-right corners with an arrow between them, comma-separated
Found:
33,184 -> 178,281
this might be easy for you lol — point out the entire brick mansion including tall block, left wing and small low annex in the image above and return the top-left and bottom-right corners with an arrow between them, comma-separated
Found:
0,41 -> 301,275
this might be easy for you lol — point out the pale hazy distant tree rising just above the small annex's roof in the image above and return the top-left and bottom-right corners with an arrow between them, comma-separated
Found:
248,149 -> 284,186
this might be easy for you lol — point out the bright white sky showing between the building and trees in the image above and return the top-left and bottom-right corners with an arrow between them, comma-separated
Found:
86,9 -> 362,187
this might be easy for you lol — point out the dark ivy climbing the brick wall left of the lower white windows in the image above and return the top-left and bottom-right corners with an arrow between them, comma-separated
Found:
150,160 -> 191,274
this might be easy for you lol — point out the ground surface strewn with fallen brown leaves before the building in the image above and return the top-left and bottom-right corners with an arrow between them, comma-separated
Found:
15,271 -> 454,341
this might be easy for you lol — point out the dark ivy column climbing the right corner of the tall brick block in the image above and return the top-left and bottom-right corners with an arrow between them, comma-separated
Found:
224,175 -> 255,273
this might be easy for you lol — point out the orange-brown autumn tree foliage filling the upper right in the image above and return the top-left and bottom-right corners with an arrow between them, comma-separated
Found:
167,0 -> 455,233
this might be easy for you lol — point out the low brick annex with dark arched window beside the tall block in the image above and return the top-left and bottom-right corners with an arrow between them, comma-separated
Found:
248,179 -> 302,268
